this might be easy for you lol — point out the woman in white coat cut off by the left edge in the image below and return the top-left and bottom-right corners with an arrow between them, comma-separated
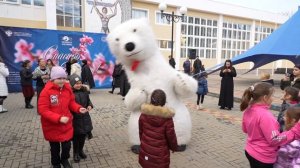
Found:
0,57 -> 9,113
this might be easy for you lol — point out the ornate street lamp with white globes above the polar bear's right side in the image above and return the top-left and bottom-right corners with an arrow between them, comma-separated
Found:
158,3 -> 187,57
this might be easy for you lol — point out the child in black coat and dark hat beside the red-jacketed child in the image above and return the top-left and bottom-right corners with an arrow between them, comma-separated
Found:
69,74 -> 93,163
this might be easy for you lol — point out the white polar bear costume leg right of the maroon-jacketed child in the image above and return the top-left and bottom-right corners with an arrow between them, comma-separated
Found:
173,104 -> 192,145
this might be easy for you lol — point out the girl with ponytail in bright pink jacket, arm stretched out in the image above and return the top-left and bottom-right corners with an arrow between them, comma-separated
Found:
240,82 -> 300,168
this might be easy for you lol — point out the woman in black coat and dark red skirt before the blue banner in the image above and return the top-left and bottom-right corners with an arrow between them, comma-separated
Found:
20,60 -> 34,109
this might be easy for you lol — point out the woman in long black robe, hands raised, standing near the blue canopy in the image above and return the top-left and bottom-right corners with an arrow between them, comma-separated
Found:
218,60 -> 236,110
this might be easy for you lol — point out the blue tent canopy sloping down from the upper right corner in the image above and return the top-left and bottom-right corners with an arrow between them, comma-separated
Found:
208,9 -> 300,73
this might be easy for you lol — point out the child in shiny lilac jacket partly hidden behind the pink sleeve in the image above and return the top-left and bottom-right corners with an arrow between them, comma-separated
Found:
274,107 -> 300,168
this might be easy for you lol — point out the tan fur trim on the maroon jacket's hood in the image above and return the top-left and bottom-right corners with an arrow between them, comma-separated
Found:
141,104 -> 175,118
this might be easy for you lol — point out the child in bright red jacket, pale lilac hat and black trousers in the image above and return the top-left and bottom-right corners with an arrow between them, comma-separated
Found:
38,66 -> 87,168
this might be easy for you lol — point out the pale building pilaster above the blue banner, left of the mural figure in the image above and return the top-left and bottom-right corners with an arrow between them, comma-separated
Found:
45,0 -> 57,30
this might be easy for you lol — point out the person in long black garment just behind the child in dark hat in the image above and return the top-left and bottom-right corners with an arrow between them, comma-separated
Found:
81,60 -> 95,88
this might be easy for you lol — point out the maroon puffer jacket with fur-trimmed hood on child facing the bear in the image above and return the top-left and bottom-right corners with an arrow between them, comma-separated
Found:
139,104 -> 178,168
